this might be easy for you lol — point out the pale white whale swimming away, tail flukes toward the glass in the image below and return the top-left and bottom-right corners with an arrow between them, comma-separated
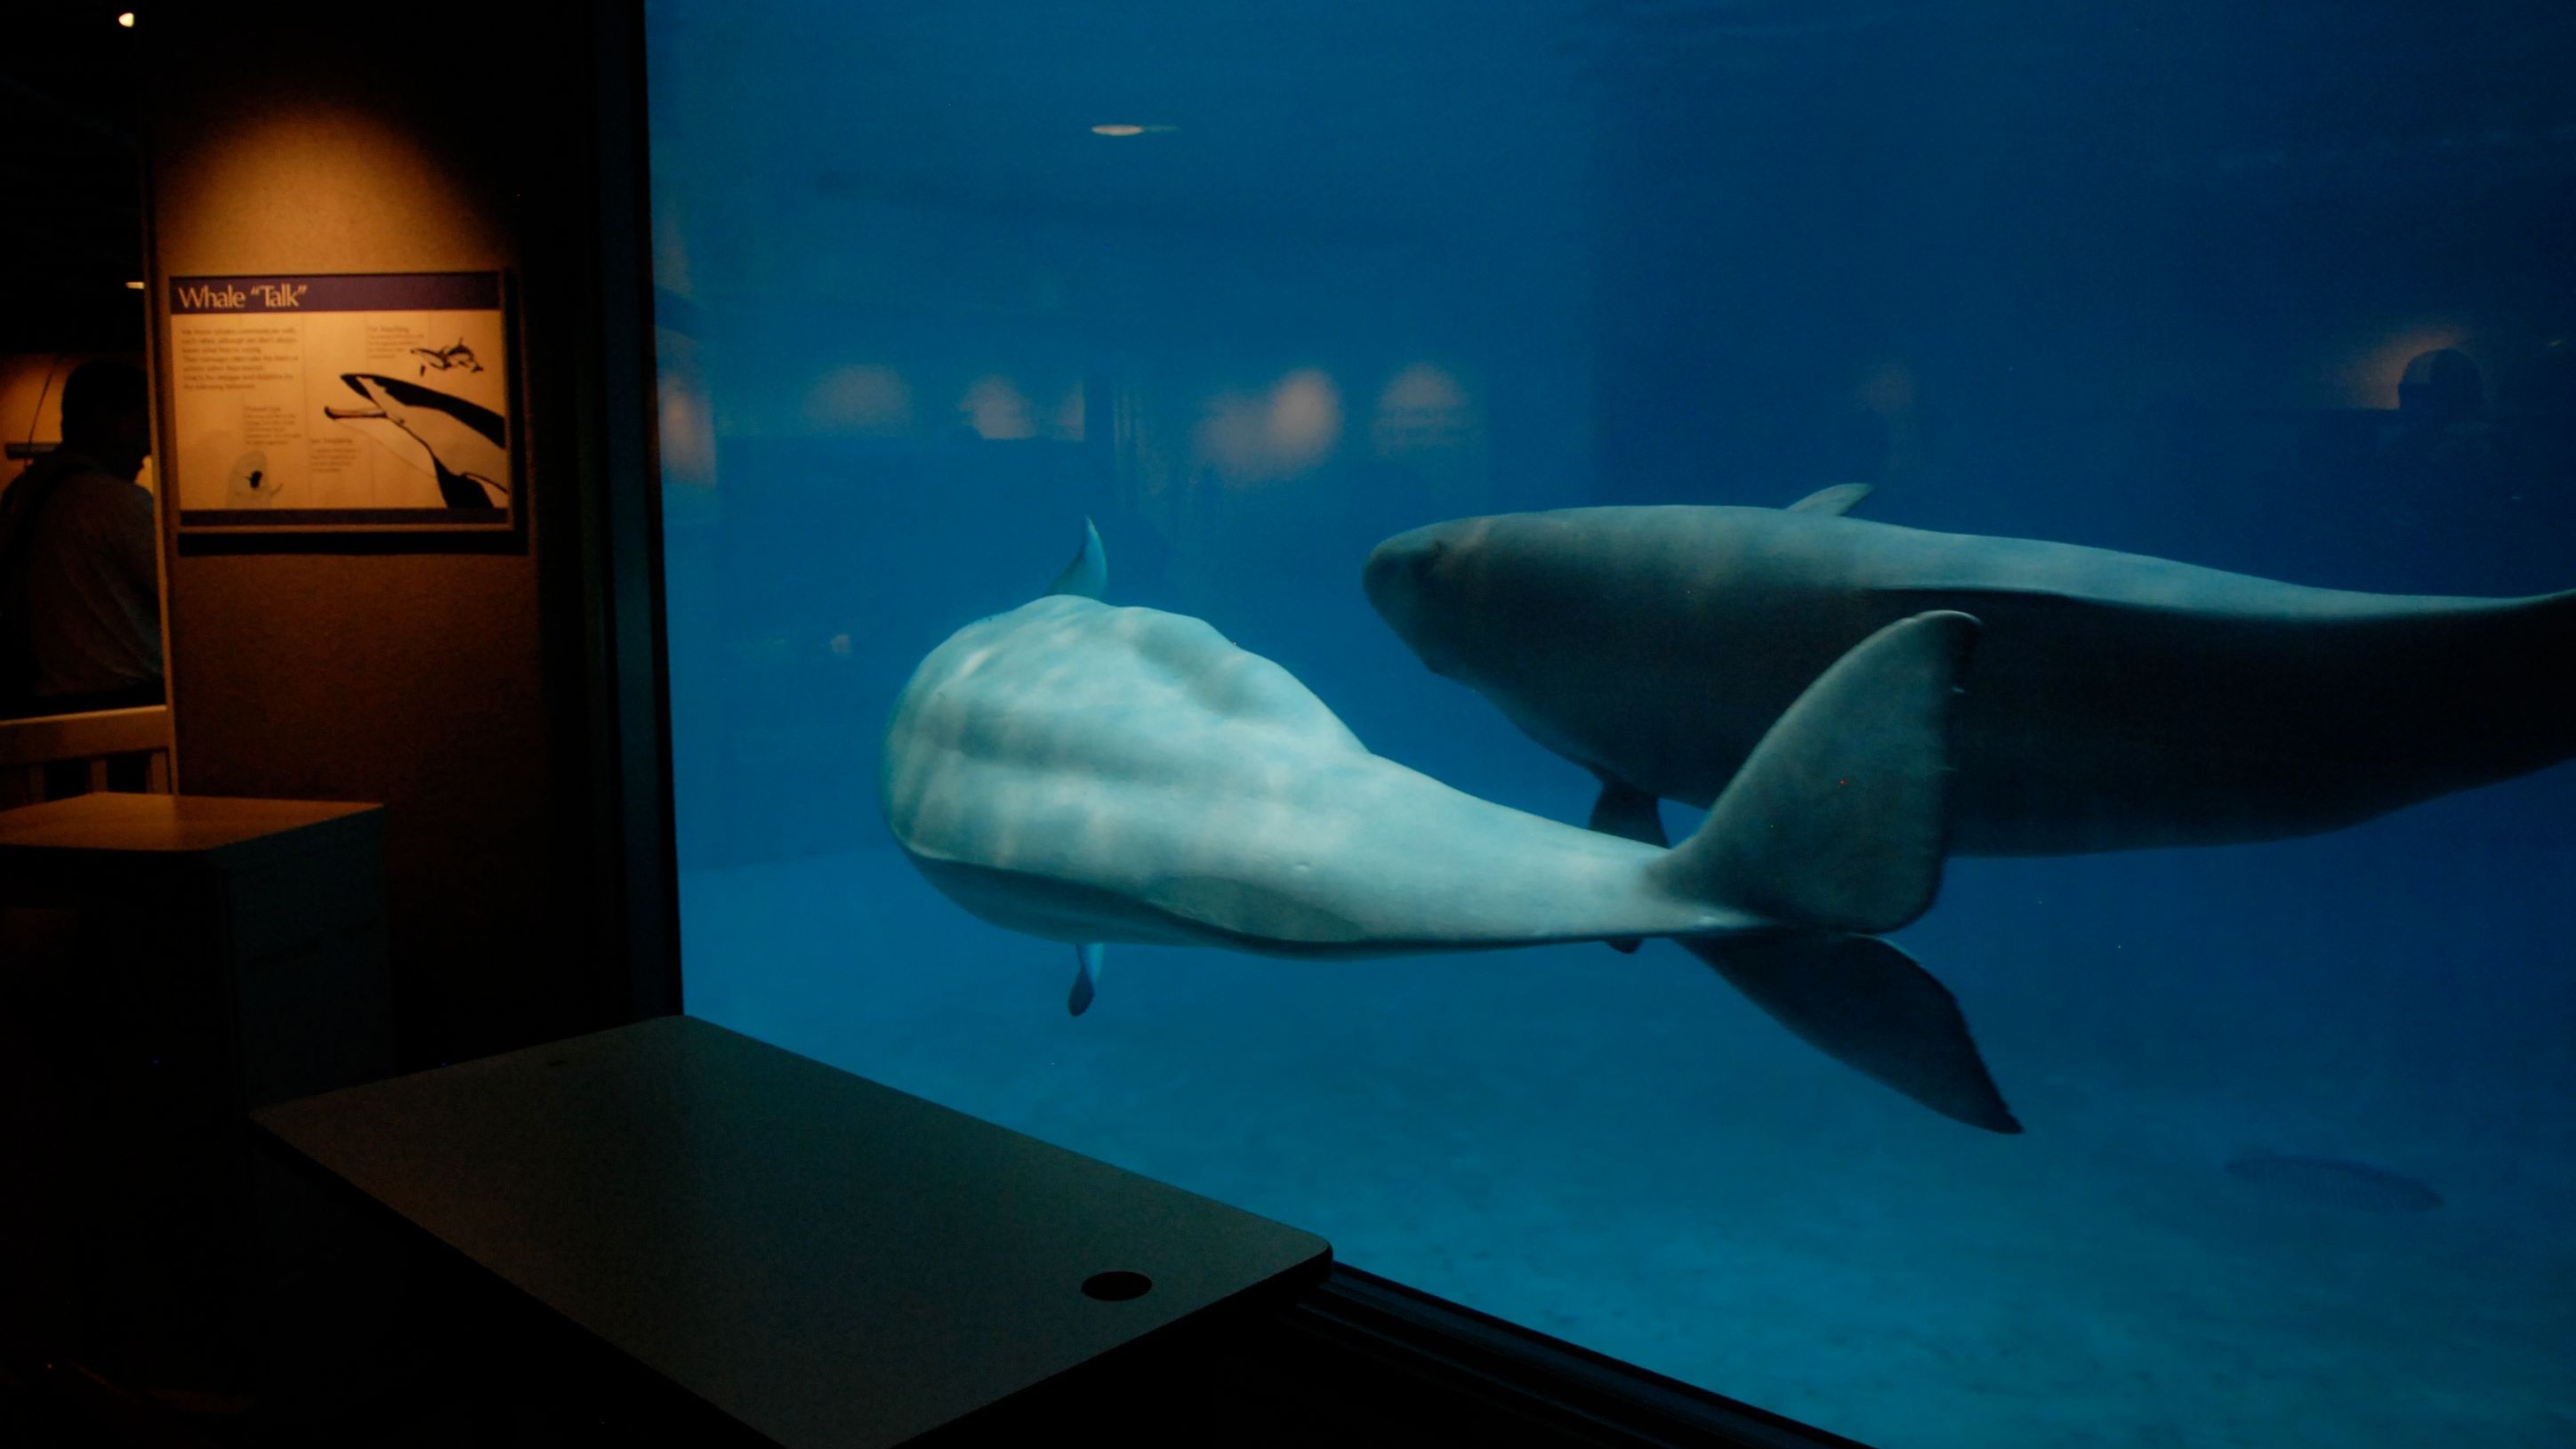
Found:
879,526 -> 2019,1131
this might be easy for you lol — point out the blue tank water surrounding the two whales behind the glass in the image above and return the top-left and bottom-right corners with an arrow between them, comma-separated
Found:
647,0 -> 2576,1449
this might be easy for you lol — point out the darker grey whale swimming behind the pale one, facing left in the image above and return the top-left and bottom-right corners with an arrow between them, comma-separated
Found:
1363,485 -> 2576,856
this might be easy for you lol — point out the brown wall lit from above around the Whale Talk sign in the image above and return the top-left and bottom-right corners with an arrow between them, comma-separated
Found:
147,0 -> 618,1065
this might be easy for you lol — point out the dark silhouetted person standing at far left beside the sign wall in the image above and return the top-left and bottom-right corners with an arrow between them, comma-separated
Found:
0,358 -> 162,714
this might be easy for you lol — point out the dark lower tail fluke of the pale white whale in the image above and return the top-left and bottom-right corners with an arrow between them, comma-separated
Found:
1682,930 -> 2022,1131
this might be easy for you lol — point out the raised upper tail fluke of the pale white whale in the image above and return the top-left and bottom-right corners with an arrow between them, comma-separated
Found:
1654,611 -> 1978,936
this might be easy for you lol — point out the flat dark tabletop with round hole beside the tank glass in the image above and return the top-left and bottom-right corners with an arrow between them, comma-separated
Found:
255,1016 -> 1332,1449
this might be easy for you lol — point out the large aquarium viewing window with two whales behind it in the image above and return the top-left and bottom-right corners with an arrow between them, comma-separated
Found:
647,0 -> 2576,1449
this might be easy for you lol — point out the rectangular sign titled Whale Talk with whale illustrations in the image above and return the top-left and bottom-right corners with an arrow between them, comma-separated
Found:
167,270 -> 518,534
